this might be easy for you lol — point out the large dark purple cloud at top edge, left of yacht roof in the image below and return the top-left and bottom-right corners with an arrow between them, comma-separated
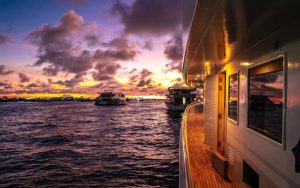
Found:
110,0 -> 182,34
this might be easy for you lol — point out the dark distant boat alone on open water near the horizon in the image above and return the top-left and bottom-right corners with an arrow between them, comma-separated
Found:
95,91 -> 126,106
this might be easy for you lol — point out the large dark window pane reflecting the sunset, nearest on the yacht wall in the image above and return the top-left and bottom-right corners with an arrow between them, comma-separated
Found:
248,58 -> 284,143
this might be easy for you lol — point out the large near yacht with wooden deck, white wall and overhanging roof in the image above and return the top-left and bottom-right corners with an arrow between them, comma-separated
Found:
180,0 -> 300,188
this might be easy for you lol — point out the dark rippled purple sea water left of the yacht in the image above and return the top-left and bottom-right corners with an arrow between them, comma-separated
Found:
0,101 -> 181,187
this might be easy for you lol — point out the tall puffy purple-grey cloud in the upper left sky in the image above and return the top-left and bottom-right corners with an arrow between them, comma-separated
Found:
28,11 -> 93,78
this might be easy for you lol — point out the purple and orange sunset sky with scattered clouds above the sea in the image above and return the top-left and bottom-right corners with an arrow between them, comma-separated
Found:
0,0 -> 194,97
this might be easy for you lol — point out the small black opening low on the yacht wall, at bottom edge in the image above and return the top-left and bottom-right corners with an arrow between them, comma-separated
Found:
243,161 -> 259,188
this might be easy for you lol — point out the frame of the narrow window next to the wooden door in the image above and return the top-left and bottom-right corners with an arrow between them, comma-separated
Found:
227,71 -> 240,125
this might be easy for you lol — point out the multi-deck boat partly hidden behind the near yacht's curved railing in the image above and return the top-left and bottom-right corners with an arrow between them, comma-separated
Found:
165,86 -> 196,111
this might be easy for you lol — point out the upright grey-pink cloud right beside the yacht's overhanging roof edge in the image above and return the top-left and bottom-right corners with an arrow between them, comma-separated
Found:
164,35 -> 183,72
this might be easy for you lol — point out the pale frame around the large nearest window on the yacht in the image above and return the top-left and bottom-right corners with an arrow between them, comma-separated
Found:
247,53 -> 287,150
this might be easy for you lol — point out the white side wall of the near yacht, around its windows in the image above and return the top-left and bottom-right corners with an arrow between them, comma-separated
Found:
205,37 -> 300,188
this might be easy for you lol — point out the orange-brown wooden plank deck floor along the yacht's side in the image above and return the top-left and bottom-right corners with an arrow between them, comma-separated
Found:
186,108 -> 237,188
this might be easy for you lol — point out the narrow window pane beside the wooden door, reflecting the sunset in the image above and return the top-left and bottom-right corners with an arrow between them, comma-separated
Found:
228,73 -> 239,122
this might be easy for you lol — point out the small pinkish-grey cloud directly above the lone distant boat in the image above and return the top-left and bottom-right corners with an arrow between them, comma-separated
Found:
92,63 -> 121,81
